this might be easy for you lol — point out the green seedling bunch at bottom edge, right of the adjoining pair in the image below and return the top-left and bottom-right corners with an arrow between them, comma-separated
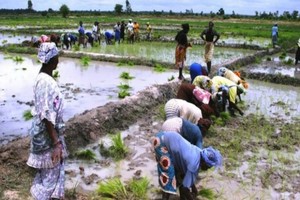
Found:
128,177 -> 149,199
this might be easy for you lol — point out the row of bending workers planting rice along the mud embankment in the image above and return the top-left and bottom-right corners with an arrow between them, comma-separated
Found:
152,63 -> 248,200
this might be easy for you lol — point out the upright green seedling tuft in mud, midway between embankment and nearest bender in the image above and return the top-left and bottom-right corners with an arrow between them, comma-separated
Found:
109,132 -> 128,160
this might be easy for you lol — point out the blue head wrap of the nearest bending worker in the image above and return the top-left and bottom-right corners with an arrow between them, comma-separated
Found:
201,147 -> 223,167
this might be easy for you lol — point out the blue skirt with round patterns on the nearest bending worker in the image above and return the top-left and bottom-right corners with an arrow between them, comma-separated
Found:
152,132 -> 177,194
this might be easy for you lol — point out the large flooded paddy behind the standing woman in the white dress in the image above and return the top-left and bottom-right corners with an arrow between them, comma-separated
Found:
0,54 -> 177,142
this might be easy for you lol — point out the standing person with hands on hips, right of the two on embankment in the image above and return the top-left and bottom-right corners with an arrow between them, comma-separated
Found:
200,21 -> 220,74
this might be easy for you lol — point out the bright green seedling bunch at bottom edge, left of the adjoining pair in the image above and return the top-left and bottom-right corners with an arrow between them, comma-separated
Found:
97,178 -> 128,200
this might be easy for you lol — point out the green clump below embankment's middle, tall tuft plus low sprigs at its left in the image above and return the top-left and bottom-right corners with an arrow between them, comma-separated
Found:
100,133 -> 128,160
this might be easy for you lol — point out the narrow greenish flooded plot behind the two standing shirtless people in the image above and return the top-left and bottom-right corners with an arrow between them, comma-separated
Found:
86,42 -> 255,66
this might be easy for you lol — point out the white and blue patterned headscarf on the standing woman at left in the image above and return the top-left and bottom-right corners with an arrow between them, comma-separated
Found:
38,42 -> 58,64
